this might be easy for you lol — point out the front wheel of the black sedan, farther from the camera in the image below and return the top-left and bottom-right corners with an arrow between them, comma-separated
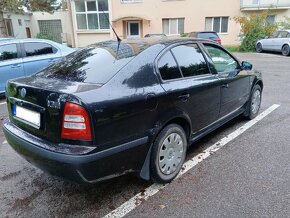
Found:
244,85 -> 262,120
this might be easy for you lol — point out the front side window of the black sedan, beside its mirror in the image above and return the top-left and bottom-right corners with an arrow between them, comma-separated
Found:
205,45 -> 239,73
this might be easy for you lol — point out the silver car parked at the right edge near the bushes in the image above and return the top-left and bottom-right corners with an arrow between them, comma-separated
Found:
256,30 -> 290,56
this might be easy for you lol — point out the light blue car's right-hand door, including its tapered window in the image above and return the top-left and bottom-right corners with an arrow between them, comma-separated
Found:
22,42 -> 61,75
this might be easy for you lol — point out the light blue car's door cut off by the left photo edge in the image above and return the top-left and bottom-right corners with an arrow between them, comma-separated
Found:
0,43 -> 24,93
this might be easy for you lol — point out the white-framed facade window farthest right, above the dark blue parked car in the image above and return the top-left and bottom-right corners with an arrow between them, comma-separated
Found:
205,17 -> 229,33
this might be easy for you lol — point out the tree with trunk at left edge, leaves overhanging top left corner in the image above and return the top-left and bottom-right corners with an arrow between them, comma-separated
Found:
0,0 -> 60,37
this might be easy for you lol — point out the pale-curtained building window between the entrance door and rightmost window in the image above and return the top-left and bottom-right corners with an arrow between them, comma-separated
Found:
162,18 -> 184,35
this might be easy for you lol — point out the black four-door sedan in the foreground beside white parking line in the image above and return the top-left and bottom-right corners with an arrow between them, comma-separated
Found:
4,38 -> 263,183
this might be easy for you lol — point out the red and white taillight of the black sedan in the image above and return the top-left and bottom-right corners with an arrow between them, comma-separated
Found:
61,102 -> 92,140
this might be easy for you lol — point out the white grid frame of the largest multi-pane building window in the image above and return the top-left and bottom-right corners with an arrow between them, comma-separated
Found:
74,0 -> 110,31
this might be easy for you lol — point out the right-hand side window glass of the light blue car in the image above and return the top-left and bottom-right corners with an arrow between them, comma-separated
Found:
24,42 -> 57,57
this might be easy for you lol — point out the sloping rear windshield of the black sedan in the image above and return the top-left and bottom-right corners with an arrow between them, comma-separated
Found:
36,42 -> 135,84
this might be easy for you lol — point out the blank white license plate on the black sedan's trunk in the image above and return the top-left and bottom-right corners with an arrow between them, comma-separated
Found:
14,105 -> 40,128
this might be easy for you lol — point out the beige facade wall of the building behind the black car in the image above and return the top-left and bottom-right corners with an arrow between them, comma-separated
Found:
69,0 -> 244,47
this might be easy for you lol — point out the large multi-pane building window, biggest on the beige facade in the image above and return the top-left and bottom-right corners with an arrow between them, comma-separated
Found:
75,0 -> 110,30
